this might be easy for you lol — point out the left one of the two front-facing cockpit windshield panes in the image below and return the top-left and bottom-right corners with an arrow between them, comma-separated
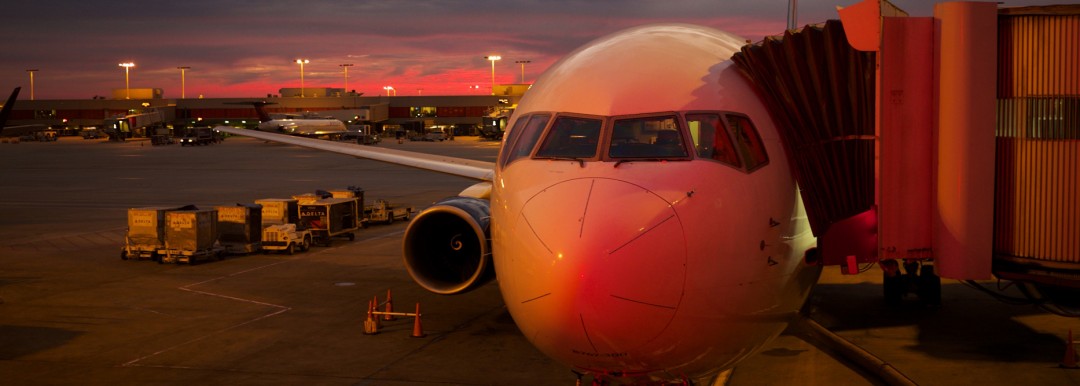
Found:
536,117 -> 603,159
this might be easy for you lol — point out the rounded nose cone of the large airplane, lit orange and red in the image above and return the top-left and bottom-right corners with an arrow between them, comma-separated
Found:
518,178 -> 687,360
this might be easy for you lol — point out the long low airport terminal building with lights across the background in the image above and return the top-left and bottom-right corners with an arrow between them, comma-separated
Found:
0,84 -> 527,135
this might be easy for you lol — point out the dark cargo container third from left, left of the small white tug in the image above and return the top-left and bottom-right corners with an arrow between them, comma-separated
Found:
214,203 -> 262,254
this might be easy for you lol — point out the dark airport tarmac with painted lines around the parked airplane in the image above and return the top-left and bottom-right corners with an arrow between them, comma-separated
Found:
0,137 -> 1080,386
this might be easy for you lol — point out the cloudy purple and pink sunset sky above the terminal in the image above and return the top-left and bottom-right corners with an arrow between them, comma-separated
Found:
0,0 -> 1059,99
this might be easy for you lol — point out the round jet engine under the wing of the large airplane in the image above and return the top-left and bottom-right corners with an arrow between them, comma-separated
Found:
404,197 -> 495,295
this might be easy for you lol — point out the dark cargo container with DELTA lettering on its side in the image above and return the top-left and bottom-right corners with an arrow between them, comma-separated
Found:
299,198 -> 360,247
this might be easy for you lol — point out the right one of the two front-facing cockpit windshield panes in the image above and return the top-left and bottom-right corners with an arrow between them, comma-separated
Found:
608,116 -> 689,158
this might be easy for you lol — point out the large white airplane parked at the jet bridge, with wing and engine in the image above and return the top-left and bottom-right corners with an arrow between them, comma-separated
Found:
212,24 -> 820,383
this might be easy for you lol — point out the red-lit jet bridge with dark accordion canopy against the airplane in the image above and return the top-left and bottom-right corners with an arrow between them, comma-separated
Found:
732,0 -> 1080,315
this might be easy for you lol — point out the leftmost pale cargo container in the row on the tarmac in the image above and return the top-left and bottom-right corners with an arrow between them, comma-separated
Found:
120,205 -> 194,261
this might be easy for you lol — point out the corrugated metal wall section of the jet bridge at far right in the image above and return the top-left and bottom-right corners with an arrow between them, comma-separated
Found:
994,9 -> 1080,266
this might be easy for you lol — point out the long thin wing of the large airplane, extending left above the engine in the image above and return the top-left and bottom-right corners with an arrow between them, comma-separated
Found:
214,127 -> 495,182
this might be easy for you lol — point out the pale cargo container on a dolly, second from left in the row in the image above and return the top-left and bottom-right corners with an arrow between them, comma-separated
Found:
158,209 -> 224,264
